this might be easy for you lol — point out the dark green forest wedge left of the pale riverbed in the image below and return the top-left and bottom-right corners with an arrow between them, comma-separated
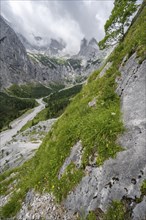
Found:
0,92 -> 37,130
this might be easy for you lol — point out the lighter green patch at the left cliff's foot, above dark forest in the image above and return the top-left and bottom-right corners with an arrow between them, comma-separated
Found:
7,83 -> 52,98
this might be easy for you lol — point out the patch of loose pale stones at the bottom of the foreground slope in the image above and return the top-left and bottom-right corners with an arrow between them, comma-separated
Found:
17,190 -> 75,220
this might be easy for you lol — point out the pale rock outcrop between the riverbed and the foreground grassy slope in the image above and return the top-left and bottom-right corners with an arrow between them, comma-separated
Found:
0,119 -> 57,173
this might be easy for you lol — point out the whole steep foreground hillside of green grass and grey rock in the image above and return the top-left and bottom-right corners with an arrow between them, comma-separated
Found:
1,1 -> 146,220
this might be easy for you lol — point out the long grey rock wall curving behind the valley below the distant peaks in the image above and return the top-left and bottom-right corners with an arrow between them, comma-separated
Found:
0,16 -> 103,90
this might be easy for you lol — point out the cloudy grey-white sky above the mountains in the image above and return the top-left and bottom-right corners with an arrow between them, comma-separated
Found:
1,0 -> 114,53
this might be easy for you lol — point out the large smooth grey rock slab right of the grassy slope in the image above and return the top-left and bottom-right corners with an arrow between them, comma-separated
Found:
64,54 -> 146,217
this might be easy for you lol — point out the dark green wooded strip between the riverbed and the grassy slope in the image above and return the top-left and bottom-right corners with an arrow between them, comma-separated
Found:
21,85 -> 82,131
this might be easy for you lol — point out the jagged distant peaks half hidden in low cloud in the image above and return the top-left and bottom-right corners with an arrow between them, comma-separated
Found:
17,33 -> 102,61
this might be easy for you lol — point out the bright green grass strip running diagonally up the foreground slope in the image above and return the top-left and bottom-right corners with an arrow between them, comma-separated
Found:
1,2 -> 146,219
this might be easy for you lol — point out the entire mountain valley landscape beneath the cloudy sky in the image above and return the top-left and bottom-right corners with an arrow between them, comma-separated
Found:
0,0 -> 146,220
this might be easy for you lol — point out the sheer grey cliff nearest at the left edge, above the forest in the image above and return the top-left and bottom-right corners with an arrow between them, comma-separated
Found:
0,17 -> 35,87
